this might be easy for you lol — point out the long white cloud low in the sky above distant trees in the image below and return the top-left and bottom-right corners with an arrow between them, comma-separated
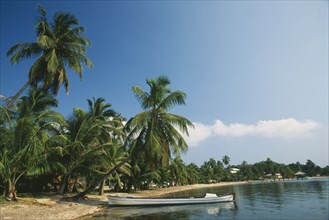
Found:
184,118 -> 319,146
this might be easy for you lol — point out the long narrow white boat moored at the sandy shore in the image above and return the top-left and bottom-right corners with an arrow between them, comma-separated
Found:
109,193 -> 235,206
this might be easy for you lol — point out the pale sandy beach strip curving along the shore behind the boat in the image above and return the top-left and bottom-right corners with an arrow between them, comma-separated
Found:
0,182 -> 248,220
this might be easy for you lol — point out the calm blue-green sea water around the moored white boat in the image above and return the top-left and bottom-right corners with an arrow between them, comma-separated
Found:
87,178 -> 329,220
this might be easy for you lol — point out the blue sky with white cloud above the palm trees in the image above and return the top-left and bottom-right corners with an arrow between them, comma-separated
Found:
0,1 -> 329,166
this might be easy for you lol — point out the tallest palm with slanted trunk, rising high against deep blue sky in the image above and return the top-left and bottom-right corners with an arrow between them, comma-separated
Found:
7,5 -> 93,108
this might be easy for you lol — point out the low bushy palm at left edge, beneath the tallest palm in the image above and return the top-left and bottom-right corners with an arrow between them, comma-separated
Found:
0,88 -> 63,200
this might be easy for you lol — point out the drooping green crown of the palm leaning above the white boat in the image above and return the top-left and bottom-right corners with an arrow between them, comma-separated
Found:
127,76 -> 193,167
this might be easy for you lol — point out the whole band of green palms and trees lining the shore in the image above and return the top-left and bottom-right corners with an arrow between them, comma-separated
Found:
0,6 -> 329,200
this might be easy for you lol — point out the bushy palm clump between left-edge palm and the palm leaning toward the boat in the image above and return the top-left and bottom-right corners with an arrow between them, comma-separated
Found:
52,98 -> 127,193
